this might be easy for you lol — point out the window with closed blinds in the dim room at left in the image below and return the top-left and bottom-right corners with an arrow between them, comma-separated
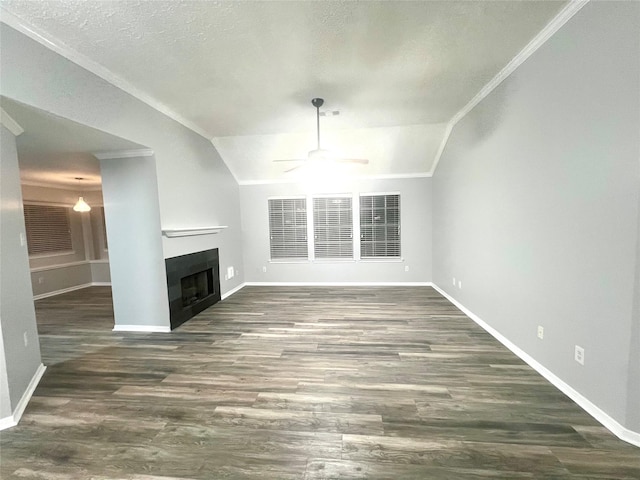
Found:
24,205 -> 73,255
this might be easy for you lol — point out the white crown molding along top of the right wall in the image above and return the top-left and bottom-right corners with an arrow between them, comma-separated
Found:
431,0 -> 590,175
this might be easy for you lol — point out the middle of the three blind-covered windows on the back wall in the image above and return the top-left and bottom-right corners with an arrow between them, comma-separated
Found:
313,197 -> 353,258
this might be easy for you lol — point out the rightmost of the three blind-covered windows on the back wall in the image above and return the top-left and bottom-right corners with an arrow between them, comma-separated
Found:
360,194 -> 400,258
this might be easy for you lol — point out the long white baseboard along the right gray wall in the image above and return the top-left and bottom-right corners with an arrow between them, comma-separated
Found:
433,284 -> 640,447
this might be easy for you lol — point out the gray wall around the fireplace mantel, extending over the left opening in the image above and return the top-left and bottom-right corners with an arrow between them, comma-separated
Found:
0,24 -> 244,294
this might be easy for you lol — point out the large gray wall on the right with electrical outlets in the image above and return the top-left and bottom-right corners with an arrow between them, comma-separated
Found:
433,2 -> 640,431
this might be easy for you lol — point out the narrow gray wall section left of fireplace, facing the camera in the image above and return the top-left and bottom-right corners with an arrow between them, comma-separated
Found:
100,157 -> 169,328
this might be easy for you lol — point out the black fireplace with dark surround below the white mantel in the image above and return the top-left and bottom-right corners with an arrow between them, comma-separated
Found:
165,248 -> 220,330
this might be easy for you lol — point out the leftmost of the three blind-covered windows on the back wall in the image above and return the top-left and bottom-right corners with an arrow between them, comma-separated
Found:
269,198 -> 309,260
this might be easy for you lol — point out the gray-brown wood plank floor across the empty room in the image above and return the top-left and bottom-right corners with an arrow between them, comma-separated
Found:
0,287 -> 640,480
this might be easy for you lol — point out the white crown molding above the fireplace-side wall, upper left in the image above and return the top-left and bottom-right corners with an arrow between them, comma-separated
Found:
0,7 -> 211,140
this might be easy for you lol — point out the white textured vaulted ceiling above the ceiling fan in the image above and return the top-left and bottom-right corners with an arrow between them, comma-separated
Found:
2,0 -> 566,181
